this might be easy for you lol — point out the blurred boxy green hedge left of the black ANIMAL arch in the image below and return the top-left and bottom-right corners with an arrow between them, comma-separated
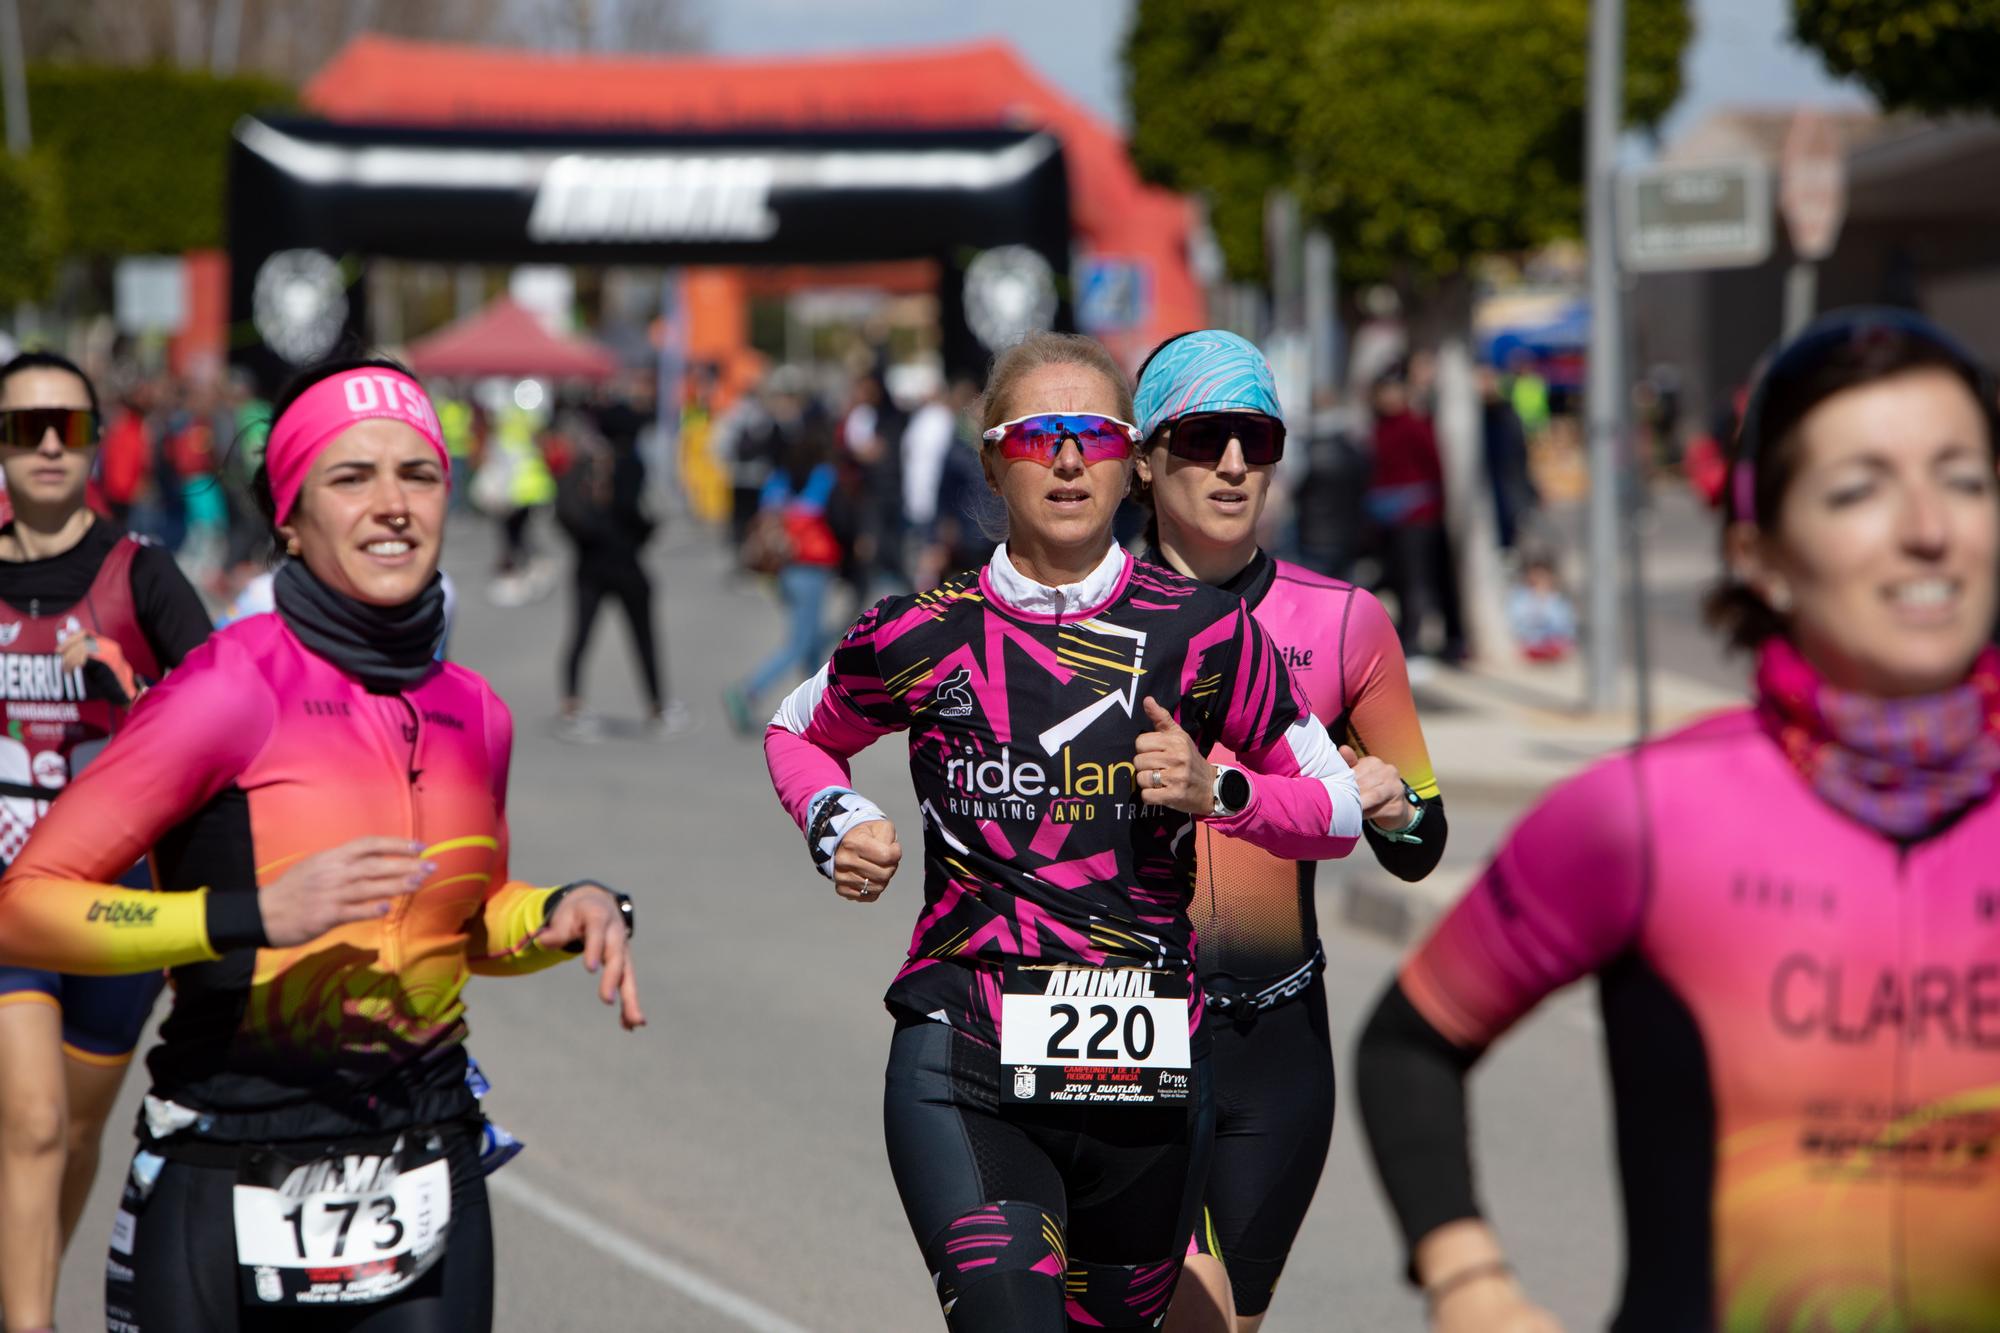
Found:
0,66 -> 294,256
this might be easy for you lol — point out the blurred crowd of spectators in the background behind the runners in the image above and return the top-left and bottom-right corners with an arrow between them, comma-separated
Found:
62,340 -> 1576,684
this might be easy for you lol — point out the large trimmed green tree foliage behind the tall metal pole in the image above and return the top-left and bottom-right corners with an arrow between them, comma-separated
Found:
1126,0 -> 1690,286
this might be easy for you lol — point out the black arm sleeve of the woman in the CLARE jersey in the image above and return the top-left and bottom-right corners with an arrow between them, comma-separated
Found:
1354,983 -> 1480,1281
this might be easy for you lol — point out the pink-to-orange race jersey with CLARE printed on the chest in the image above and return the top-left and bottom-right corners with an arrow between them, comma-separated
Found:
1402,711 -> 2000,1333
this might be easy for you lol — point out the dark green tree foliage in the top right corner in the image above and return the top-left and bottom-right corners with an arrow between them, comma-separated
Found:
1792,0 -> 2000,116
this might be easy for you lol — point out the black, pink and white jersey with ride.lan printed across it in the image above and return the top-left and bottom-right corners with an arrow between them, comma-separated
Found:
766,548 -> 1360,1041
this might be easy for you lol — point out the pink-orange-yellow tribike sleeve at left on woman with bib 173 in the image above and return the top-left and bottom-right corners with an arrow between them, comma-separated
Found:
0,640 -> 274,964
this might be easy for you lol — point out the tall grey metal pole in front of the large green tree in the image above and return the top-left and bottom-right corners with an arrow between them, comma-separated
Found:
1584,0 -> 1626,713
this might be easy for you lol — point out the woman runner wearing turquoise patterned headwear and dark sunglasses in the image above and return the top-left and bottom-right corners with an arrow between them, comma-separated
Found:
1136,328 -> 1444,1333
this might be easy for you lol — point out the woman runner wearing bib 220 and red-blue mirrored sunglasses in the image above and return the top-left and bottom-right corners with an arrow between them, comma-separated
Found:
764,334 -> 1362,1333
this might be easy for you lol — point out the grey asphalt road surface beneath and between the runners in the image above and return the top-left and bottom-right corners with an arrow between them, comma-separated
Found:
60,526 -> 1618,1333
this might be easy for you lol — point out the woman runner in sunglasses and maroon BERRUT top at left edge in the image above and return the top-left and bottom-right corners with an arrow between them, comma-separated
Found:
0,352 -> 208,1331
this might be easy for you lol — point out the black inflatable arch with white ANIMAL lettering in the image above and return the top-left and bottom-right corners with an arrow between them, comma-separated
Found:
228,118 -> 1072,386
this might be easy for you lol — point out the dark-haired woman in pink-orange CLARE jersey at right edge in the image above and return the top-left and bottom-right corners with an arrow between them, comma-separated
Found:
1356,310 -> 2000,1333
